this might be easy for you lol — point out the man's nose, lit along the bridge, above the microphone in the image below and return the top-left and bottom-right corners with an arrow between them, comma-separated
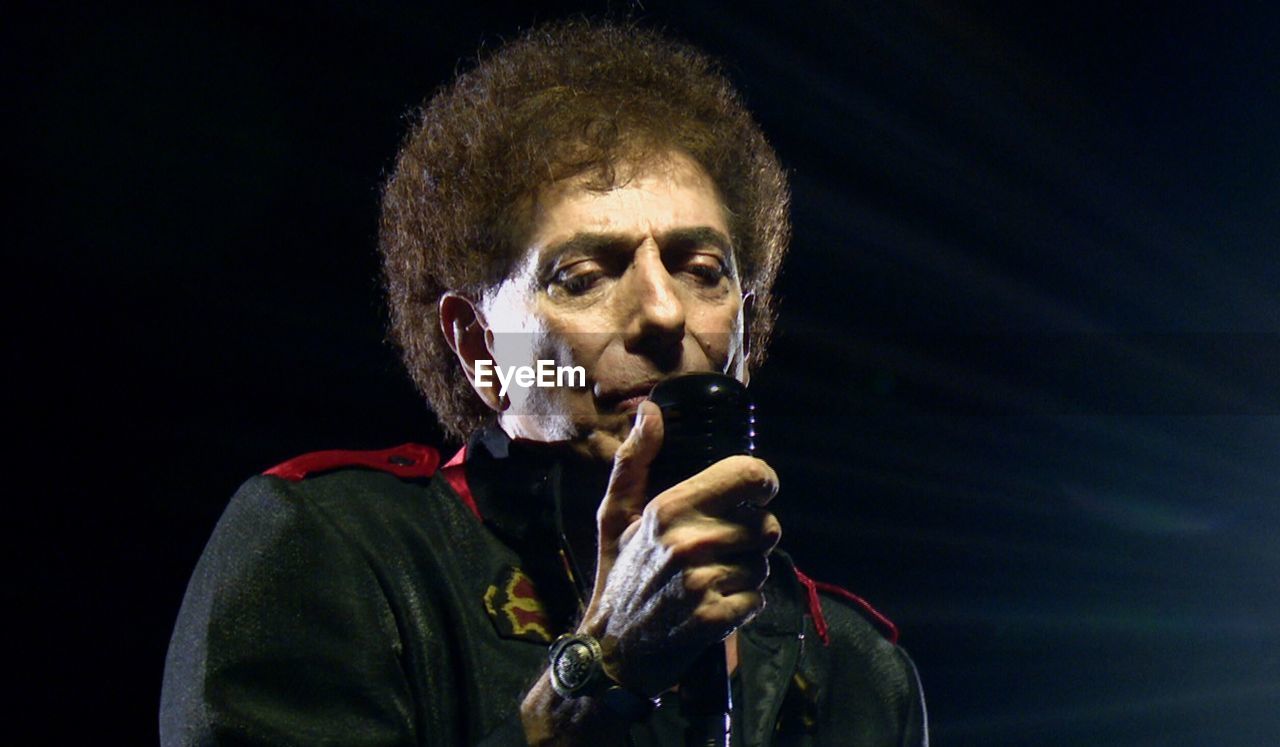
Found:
623,242 -> 685,368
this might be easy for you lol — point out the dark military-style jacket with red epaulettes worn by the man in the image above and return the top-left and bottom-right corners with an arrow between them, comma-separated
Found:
160,430 -> 928,746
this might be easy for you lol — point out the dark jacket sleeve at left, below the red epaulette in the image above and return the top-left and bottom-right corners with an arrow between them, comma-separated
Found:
160,477 -> 419,746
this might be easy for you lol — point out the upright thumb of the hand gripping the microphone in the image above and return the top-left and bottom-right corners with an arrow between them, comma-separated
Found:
596,399 -> 663,560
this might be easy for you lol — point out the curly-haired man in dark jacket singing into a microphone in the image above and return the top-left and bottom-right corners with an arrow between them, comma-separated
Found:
161,22 -> 927,744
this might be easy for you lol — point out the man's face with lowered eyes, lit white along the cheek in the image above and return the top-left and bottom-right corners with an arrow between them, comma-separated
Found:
480,153 -> 746,459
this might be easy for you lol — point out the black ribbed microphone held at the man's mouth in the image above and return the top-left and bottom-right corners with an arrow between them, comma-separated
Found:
649,374 -> 755,747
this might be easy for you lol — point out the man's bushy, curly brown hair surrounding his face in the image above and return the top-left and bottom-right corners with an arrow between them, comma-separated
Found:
379,20 -> 790,437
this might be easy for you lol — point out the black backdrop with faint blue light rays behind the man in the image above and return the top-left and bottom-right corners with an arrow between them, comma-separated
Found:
12,0 -> 1280,744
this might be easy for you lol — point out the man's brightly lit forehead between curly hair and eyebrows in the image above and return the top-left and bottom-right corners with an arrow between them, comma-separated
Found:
526,152 -> 728,253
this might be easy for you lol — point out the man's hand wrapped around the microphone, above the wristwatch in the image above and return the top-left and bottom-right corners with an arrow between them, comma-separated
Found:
580,402 -> 782,695
